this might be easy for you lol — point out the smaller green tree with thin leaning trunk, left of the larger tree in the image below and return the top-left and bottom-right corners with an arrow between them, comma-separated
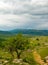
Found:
3,37 -> 14,58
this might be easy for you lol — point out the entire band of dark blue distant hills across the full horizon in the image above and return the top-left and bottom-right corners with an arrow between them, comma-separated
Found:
0,29 -> 48,36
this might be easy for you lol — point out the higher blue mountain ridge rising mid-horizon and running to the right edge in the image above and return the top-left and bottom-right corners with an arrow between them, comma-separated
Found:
10,29 -> 48,36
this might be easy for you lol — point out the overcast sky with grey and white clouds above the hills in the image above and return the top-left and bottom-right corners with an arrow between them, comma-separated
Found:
0,0 -> 48,30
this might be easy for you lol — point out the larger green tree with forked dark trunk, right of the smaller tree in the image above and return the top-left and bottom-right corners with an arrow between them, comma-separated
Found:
14,34 -> 29,59
